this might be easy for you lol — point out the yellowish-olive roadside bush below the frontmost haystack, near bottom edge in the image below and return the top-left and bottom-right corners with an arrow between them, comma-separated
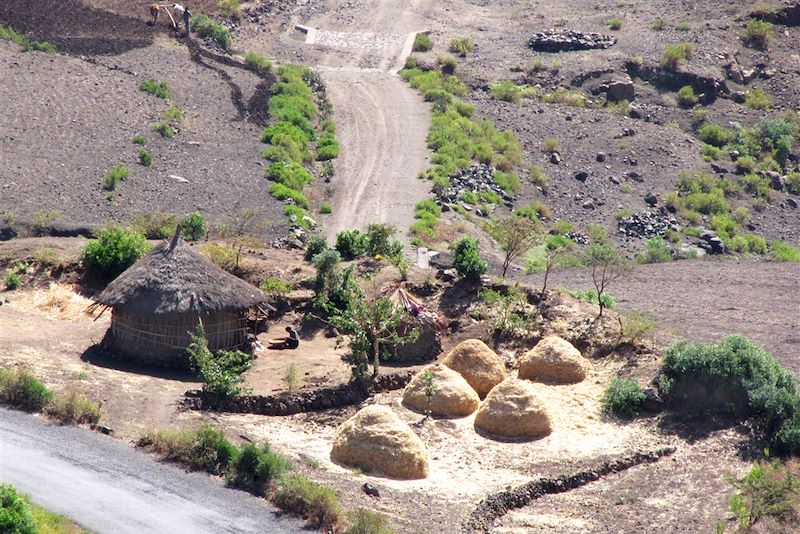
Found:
274,475 -> 343,530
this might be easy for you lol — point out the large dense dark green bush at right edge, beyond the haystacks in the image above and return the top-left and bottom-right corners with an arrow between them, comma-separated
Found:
661,334 -> 800,454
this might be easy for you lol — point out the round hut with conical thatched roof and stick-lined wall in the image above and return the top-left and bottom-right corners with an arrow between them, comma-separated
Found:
93,232 -> 269,368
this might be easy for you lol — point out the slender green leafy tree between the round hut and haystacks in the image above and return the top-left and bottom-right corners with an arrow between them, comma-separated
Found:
330,288 -> 419,382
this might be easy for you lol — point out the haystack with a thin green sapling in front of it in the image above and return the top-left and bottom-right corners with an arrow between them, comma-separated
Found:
403,364 -> 480,417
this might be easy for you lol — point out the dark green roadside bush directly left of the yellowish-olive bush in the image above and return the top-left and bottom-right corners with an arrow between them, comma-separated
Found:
228,443 -> 292,495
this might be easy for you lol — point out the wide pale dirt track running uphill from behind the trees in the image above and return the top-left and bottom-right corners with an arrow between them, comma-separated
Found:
296,0 -> 430,237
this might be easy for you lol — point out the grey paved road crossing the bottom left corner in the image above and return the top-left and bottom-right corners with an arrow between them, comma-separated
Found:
0,409 -> 303,534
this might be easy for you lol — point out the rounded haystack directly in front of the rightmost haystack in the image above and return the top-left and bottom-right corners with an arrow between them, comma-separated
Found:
475,378 -> 553,438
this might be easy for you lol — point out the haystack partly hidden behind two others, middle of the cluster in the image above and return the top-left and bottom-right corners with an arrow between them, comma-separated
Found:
442,339 -> 506,398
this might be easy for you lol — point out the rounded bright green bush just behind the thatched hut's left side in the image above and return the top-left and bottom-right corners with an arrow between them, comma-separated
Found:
83,226 -> 150,280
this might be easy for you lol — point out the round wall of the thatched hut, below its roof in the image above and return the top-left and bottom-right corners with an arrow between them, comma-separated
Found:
110,309 -> 247,369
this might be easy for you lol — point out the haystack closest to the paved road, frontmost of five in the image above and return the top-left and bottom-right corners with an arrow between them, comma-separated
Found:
331,405 -> 428,479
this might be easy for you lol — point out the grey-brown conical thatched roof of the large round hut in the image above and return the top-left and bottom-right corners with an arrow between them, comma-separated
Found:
95,235 -> 267,315
